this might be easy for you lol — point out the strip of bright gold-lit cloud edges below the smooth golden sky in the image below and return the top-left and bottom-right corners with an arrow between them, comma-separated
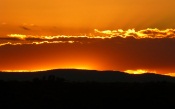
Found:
0,28 -> 175,46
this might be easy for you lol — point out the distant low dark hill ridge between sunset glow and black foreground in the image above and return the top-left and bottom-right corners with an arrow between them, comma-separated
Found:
0,69 -> 175,82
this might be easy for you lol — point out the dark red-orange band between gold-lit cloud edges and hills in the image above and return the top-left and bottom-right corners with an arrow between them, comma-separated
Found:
0,37 -> 175,73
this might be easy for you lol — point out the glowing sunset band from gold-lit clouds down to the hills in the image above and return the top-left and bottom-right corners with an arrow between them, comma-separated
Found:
0,29 -> 175,75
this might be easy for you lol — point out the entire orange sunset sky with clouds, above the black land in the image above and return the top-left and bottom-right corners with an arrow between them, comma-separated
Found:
0,0 -> 175,75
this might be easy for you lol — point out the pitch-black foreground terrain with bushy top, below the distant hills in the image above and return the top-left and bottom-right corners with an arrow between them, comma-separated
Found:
0,70 -> 175,109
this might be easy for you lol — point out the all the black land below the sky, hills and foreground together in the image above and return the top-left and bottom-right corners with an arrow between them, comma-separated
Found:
0,69 -> 175,109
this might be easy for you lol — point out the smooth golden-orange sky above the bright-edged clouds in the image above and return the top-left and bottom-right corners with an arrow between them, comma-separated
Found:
0,0 -> 175,32
